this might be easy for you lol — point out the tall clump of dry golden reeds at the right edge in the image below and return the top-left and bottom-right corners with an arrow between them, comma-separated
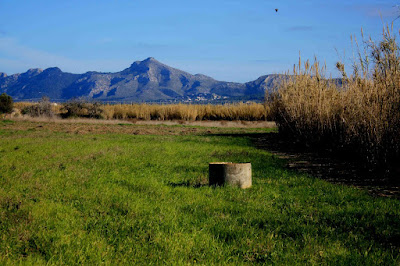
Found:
268,27 -> 400,169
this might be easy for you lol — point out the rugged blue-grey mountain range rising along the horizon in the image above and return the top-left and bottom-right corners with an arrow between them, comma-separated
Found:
0,57 -> 282,102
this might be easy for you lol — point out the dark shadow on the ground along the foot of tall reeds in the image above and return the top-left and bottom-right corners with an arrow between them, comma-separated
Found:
214,132 -> 400,199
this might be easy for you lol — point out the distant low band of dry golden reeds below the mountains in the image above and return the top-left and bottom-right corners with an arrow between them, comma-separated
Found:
15,102 -> 269,121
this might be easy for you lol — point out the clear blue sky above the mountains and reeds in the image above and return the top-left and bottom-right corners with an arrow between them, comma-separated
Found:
0,0 -> 400,82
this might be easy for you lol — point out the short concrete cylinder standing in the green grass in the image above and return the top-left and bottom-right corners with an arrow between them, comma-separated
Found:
208,162 -> 251,188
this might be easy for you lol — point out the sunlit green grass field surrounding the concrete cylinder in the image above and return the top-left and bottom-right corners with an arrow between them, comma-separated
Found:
0,121 -> 400,265
